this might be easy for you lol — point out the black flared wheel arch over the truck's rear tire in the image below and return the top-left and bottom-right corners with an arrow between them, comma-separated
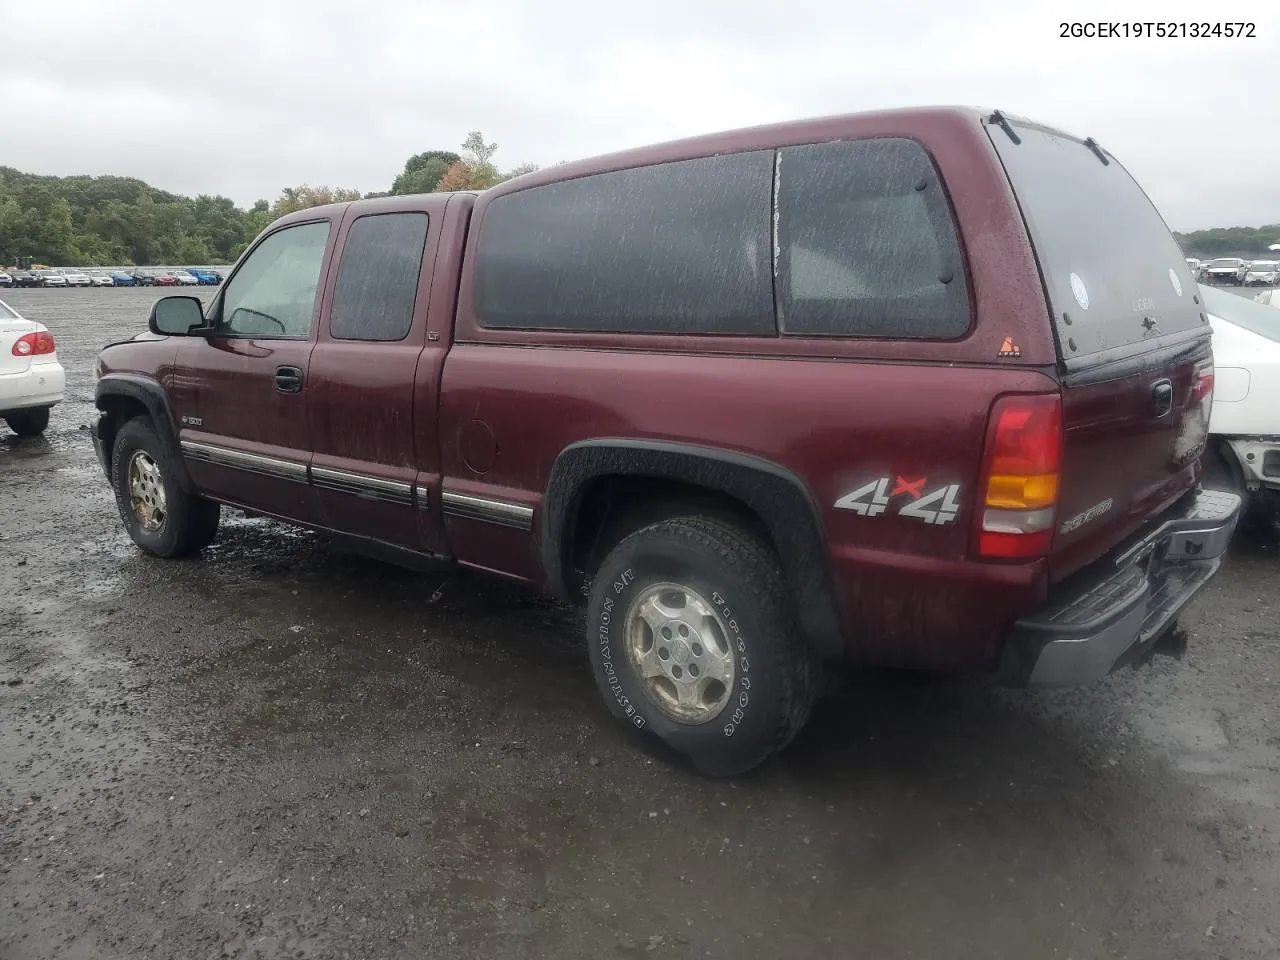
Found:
539,438 -> 844,660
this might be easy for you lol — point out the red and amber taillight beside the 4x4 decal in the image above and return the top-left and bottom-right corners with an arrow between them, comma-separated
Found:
975,393 -> 1062,559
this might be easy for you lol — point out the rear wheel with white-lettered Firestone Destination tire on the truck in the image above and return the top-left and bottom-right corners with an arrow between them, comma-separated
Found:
588,517 -> 818,777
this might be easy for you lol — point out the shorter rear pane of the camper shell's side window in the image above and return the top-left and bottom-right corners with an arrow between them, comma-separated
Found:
778,138 -> 969,339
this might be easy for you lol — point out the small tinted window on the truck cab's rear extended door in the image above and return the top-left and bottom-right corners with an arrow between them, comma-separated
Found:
329,212 -> 426,340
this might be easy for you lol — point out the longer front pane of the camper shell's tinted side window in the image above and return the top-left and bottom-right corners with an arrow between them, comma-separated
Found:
475,151 -> 774,334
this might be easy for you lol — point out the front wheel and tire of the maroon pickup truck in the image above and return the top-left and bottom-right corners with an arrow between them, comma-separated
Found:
111,417 -> 221,559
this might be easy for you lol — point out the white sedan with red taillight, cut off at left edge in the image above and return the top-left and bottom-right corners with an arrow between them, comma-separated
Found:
0,300 -> 67,436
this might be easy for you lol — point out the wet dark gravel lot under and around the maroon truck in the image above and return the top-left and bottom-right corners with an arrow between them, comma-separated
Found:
0,289 -> 1280,960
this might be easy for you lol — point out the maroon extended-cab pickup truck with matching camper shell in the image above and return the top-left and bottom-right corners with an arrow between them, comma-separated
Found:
93,109 -> 1239,774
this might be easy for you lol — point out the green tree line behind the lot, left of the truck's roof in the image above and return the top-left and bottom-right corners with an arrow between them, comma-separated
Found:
0,131 -> 538,266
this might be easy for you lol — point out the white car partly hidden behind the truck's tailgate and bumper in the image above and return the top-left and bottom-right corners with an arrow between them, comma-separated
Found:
1199,285 -> 1280,530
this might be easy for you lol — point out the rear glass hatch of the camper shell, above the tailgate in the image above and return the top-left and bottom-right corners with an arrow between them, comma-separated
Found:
987,122 -> 1208,367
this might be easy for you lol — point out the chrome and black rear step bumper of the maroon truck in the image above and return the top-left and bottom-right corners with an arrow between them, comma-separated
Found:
997,490 -> 1240,686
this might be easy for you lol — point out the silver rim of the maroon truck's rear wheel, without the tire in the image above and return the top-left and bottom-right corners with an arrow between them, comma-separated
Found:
626,582 -> 735,724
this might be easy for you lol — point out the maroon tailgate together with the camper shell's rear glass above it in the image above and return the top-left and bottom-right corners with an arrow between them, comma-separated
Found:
987,112 -> 1213,580
